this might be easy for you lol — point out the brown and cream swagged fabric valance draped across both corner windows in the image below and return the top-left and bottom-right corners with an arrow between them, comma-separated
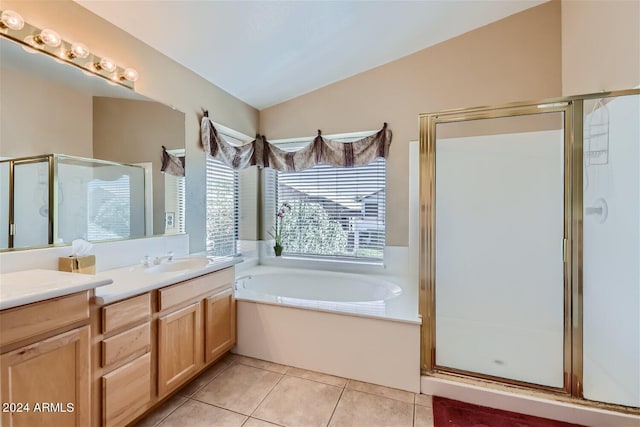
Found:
200,115 -> 391,172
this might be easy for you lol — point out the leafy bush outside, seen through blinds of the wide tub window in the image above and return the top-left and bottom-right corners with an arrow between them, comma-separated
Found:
282,200 -> 347,255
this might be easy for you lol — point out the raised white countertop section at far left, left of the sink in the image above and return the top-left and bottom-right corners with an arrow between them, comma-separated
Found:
0,269 -> 113,310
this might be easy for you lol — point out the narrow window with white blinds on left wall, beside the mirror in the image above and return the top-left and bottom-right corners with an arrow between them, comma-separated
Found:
206,130 -> 251,256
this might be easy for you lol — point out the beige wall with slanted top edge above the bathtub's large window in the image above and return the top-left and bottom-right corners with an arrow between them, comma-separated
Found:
260,1 -> 562,246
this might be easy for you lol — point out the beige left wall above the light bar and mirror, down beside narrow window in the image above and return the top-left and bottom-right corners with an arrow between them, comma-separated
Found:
0,0 -> 258,252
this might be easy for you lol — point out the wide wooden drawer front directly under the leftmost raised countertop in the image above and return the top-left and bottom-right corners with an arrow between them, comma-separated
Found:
0,291 -> 89,346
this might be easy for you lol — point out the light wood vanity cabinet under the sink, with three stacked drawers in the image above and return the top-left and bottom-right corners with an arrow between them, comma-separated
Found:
90,267 -> 236,427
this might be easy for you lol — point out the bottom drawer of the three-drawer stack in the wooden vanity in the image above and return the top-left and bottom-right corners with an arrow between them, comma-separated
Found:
102,353 -> 151,426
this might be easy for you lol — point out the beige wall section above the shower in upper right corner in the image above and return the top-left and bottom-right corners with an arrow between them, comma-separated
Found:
562,0 -> 640,95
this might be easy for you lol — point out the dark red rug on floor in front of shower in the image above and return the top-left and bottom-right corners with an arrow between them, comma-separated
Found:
433,396 -> 583,427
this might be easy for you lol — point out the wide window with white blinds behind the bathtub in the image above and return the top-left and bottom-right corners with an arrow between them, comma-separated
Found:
274,135 -> 386,261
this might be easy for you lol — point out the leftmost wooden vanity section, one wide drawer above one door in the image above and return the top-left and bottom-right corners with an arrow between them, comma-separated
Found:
0,291 -> 91,427
